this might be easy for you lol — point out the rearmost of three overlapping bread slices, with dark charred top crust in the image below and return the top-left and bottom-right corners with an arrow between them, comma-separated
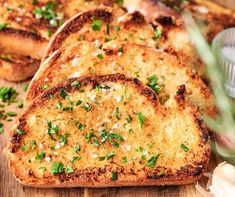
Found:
43,7 -> 156,60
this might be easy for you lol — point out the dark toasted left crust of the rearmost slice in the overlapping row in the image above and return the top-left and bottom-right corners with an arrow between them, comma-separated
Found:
42,7 -> 113,61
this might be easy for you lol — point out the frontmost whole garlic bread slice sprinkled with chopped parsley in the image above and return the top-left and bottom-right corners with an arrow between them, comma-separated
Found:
6,74 -> 210,187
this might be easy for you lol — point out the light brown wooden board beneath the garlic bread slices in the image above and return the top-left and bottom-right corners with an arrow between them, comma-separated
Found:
0,80 -> 218,197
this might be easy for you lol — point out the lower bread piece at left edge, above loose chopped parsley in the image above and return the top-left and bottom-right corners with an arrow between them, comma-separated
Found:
0,53 -> 40,81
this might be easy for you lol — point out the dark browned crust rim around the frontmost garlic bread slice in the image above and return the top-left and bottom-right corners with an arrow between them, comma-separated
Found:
7,74 -> 210,188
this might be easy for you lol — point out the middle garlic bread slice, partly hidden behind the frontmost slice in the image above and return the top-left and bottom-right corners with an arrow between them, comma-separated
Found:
26,41 -> 215,115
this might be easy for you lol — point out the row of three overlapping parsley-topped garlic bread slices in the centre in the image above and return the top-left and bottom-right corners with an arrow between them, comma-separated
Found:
6,3 -> 215,187
